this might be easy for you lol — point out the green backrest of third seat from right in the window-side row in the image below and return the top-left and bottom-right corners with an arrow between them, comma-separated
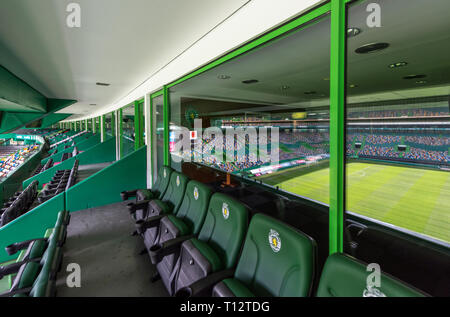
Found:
198,193 -> 248,269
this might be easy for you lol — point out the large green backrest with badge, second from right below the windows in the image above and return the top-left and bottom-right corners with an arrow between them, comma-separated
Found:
235,214 -> 316,297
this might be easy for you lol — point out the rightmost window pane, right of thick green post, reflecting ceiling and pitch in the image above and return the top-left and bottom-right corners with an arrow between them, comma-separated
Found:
346,0 -> 450,242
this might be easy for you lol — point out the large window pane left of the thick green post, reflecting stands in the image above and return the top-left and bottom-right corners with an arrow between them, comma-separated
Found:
170,17 -> 330,203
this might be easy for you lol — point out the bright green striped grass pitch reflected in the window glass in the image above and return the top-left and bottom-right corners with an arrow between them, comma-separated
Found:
259,163 -> 450,242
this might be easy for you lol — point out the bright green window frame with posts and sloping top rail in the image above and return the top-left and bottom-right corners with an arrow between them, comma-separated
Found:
91,0 -> 351,254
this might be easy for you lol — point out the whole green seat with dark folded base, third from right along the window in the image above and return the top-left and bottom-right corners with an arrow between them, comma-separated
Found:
168,193 -> 248,297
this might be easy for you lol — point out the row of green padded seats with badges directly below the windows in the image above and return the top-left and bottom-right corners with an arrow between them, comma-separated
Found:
125,167 -> 426,297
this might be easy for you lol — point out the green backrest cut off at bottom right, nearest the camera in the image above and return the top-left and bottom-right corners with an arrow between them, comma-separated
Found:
317,253 -> 425,297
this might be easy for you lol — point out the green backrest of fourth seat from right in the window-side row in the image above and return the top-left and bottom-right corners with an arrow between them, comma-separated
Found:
176,181 -> 211,234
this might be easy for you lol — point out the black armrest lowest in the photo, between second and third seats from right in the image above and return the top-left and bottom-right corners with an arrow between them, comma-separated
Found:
175,269 -> 234,298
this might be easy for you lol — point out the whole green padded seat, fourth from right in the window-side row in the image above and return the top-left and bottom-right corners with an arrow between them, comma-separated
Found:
147,181 -> 211,289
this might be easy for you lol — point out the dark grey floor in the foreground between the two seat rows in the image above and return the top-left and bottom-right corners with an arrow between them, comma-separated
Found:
56,202 -> 168,297
